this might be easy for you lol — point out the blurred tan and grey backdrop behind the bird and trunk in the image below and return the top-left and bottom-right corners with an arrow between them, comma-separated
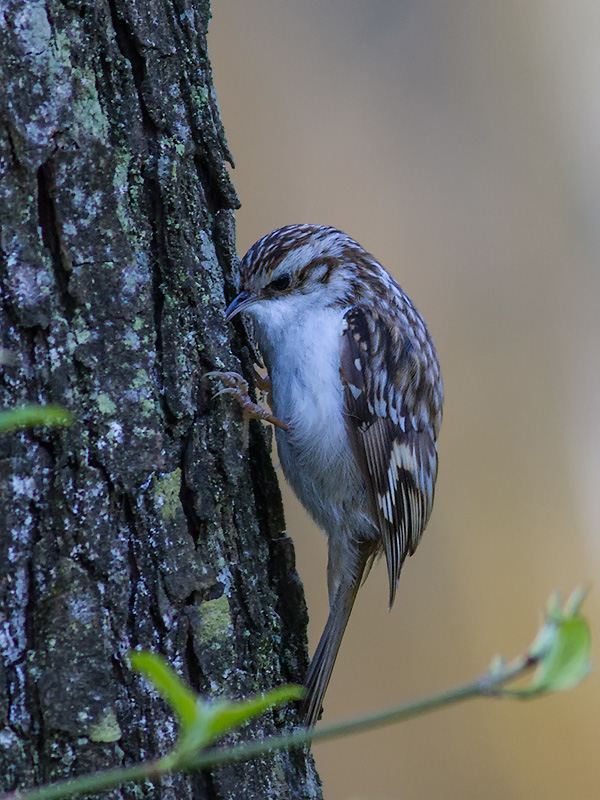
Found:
209,0 -> 600,800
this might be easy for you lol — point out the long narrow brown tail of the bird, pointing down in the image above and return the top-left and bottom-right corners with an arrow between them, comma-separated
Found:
300,558 -> 367,728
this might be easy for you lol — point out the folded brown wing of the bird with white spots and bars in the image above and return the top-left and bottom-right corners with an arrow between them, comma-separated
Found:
340,306 -> 442,607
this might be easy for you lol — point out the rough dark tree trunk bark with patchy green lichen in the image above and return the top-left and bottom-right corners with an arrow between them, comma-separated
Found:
0,0 -> 320,800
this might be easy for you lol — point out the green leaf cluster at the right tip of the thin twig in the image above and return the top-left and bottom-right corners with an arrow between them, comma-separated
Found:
502,589 -> 592,697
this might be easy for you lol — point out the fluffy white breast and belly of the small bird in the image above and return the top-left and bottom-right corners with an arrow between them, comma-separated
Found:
246,296 -> 357,528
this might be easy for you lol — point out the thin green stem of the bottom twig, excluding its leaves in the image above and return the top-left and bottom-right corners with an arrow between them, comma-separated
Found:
0,658 -> 537,800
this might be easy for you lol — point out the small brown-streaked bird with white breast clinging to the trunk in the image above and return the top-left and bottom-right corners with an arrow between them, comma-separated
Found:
211,224 -> 444,728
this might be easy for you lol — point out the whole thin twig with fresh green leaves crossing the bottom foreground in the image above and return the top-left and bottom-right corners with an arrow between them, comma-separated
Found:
0,589 -> 591,800
